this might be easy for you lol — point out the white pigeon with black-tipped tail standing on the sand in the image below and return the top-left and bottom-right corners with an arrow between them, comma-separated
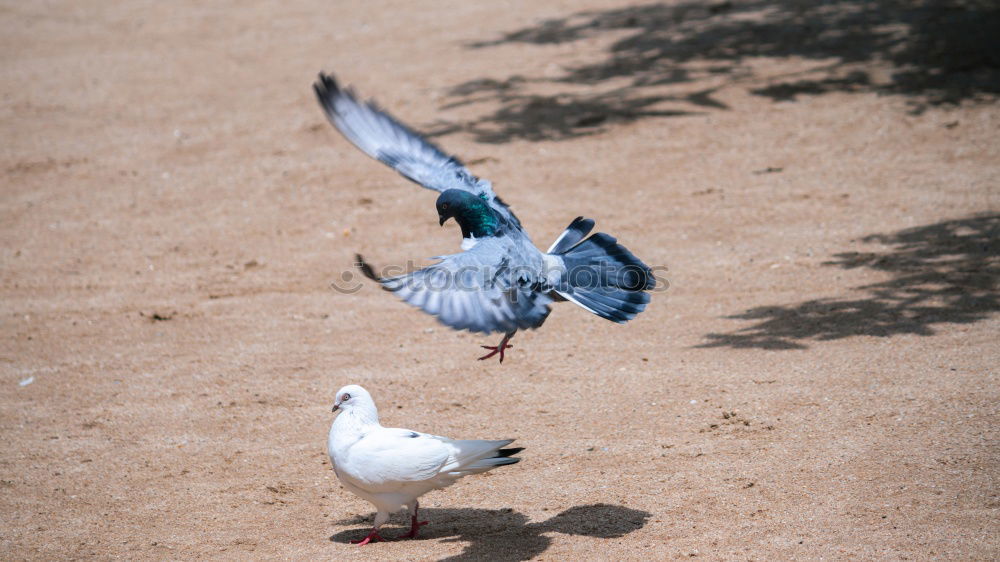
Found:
327,384 -> 524,545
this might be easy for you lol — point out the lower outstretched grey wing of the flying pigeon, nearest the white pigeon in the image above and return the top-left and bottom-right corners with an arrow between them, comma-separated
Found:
358,238 -> 552,334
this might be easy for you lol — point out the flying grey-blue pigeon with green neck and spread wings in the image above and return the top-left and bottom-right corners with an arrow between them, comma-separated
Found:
313,73 -> 656,363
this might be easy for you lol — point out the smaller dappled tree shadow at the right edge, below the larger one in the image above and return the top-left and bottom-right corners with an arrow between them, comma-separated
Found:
698,215 -> 1000,349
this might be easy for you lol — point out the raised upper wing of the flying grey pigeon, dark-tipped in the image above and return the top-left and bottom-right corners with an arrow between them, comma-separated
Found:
313,73 -> 517,222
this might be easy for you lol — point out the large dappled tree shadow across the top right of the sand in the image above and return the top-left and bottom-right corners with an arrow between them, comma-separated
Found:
431,0 -> 1000,143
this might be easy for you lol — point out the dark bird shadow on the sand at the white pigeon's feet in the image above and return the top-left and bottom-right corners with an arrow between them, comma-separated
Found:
330,504 -> 650,561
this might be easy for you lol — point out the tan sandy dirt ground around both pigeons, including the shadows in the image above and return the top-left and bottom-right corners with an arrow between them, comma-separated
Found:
0,0 -> 1000,560
